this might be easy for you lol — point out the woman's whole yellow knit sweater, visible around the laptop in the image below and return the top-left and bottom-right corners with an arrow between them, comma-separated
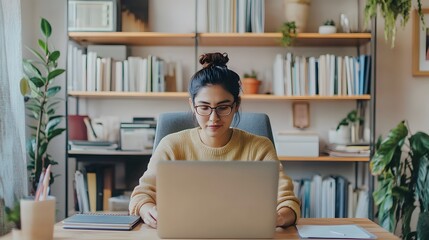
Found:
129,128 -> 300,220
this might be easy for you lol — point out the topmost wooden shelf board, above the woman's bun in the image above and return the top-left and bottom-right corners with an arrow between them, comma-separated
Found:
69,32 -> 371,47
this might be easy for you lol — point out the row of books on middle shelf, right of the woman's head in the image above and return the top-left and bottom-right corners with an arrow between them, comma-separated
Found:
273,53 -> 371,96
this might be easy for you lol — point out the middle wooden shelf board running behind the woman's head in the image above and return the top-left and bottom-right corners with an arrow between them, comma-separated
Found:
68,91 -> 371,101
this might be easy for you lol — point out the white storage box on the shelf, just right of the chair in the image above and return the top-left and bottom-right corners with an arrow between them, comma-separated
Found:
275,133 -> 319,157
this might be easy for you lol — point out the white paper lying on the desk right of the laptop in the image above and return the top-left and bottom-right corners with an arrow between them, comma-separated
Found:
296,224 -> 377,239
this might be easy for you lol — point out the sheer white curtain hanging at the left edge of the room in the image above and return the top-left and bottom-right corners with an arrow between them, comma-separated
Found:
0,0 -> 28,235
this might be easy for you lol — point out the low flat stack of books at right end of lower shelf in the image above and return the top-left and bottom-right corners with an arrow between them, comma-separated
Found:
326,144 -> 370,157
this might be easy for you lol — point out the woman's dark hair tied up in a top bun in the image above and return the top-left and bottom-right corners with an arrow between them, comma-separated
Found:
188,52 -> 241,105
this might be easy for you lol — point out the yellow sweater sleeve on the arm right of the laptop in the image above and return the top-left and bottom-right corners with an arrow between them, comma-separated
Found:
256,139 -> 301,224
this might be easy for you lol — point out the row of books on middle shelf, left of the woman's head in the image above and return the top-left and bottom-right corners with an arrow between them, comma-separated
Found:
68,44 -> 183,92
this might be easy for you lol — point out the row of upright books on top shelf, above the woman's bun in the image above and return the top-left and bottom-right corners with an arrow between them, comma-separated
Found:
205,0 -> 265,33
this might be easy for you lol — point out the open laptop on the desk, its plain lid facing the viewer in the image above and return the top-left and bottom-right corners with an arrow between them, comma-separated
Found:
156,161 -> 279,239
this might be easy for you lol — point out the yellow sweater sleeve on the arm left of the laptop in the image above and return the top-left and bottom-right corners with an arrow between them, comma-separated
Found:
129,138 -> 174,215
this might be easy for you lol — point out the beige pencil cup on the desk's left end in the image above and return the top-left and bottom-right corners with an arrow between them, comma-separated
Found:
21,196 -> 56,240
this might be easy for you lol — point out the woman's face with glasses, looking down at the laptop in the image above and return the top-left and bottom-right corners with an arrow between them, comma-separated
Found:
189,85 -> 238,147
